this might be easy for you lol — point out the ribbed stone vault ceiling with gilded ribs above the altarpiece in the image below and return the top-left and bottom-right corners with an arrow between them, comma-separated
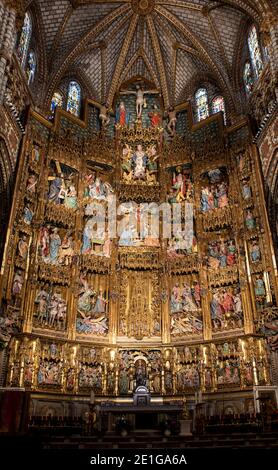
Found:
25,0 -> 271,106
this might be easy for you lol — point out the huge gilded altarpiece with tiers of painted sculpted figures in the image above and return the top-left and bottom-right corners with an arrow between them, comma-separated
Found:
1,105 -> 278,404
